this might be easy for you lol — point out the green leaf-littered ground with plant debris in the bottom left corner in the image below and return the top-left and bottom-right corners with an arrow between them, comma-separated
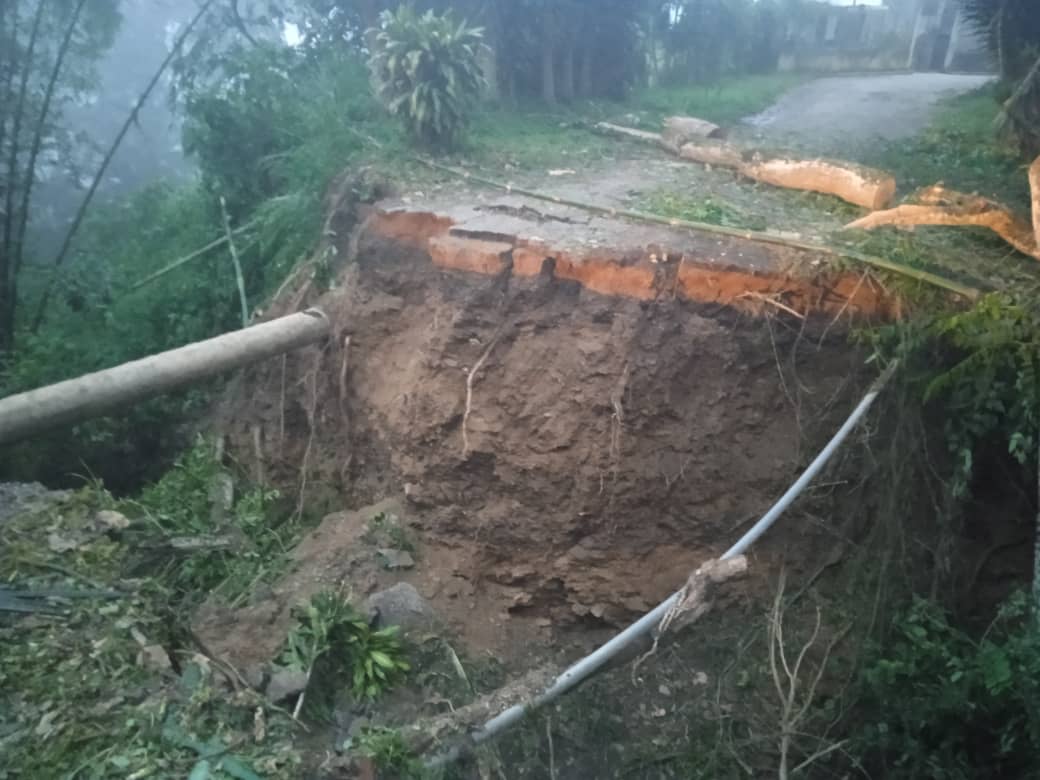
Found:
0,487 -> 300,780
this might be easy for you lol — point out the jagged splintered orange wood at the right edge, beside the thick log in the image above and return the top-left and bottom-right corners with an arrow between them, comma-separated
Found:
847,184 -> 1040,260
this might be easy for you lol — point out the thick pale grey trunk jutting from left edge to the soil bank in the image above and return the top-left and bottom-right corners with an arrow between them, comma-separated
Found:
0,309 -> 330,444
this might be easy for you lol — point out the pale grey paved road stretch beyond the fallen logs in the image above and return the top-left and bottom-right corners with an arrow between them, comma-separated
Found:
744,73 -> 989,154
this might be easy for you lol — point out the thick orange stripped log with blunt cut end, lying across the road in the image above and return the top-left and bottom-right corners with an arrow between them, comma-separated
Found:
740,157 -> 895,210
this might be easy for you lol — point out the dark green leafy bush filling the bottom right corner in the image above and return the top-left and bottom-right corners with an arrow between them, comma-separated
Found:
855,596 -> 1040,780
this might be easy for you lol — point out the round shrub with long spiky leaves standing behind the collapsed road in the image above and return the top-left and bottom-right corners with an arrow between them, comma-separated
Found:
369,5 -> 485,149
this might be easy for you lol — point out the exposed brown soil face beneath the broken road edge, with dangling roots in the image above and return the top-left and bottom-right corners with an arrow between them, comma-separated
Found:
211,209 -> 861,661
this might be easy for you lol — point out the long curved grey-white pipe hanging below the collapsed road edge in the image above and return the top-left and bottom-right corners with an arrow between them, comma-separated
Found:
426,361 -> 899,768
